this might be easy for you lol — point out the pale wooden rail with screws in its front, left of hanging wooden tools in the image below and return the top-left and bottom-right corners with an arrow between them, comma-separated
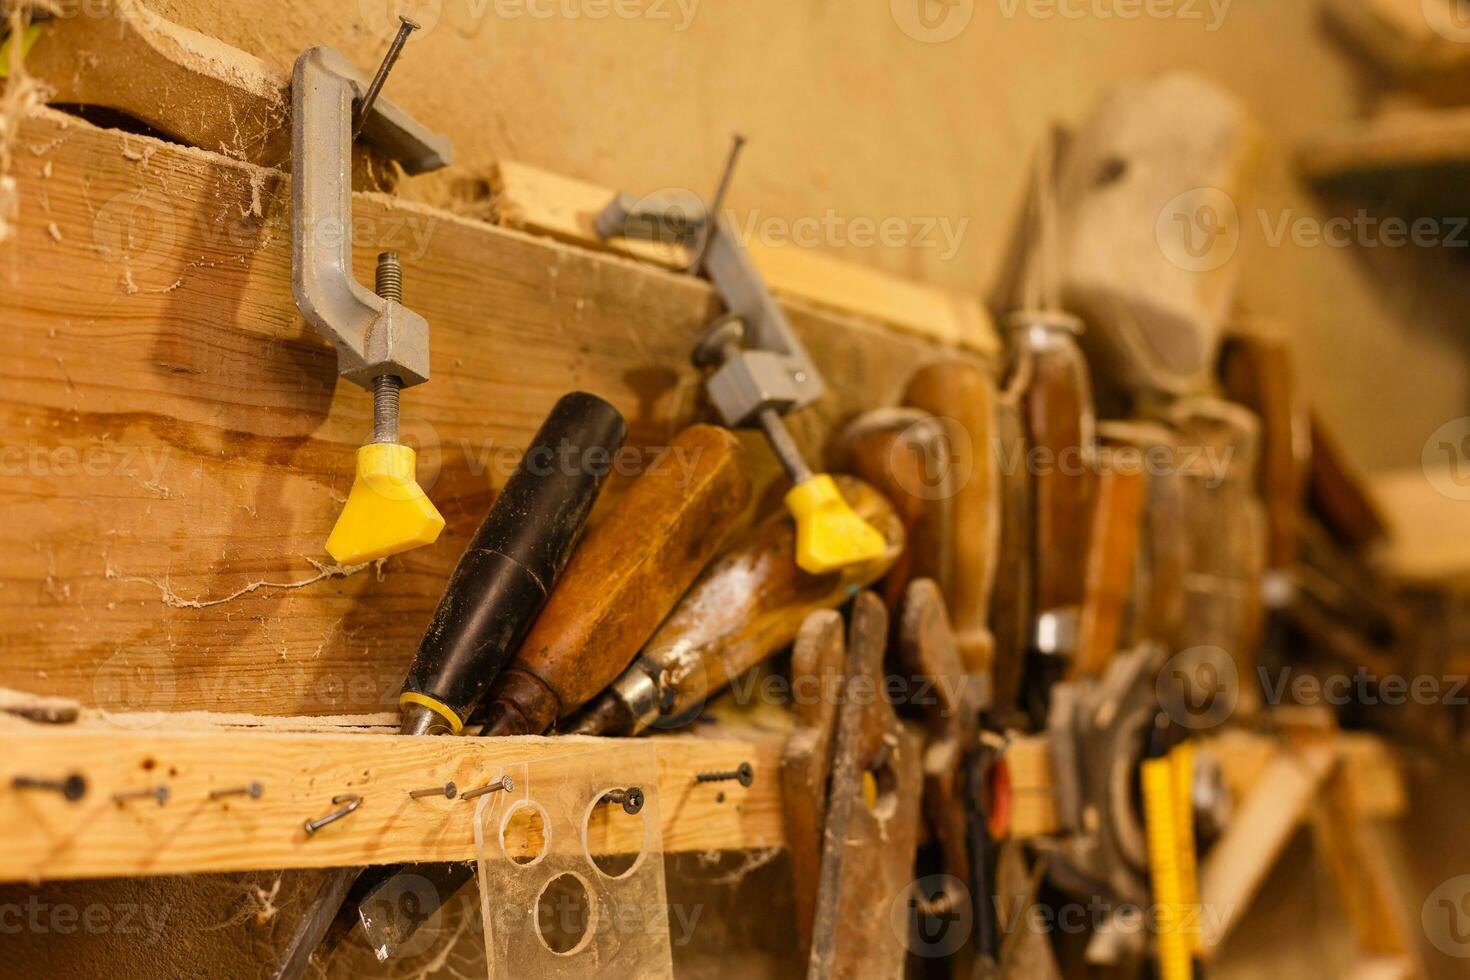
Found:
0,724 -> 785,880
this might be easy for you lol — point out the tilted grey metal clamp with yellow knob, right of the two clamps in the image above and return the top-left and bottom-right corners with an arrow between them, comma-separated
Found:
597,137 -> 885,574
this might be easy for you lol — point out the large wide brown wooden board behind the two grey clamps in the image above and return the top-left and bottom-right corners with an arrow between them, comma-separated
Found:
0,110 -> 976,714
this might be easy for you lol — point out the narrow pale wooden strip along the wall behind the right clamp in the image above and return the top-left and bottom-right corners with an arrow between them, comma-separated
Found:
491,160 -> 1001,357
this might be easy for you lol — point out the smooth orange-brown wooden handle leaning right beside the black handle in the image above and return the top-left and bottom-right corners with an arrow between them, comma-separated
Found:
484,425 -> 750,735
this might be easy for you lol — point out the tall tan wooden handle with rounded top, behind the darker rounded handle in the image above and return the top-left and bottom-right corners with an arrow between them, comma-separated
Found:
904,360 -> 1004,674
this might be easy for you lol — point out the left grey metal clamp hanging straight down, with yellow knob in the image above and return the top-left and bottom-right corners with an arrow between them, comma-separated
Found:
291,32 -> 454,564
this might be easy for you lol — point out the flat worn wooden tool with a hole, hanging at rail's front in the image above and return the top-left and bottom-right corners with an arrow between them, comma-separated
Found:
807,592 -> 922,980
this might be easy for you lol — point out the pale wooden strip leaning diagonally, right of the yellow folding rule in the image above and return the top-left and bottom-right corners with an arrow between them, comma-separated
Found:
1200,745 -> 1338,958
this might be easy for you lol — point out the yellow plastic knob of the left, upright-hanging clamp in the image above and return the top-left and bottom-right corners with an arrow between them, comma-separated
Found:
326,442 -> 444,564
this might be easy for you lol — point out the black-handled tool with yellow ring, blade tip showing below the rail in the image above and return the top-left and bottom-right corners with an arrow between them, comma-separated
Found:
275,391 -> 628,980
